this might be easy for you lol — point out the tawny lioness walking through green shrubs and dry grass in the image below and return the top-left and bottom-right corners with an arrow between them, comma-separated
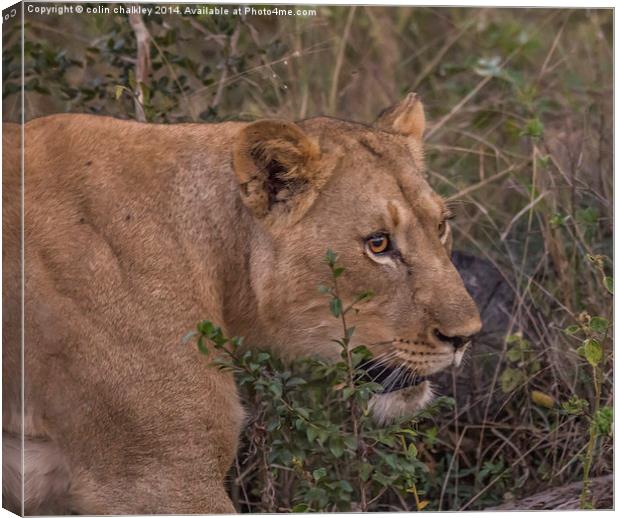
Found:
3,94 -> 480,514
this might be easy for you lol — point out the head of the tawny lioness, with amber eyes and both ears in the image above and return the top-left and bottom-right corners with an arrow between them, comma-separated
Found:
233,94 -> 480,418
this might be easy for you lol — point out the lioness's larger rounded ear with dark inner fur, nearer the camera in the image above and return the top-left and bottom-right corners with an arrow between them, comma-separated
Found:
233,120 -> 322,226
